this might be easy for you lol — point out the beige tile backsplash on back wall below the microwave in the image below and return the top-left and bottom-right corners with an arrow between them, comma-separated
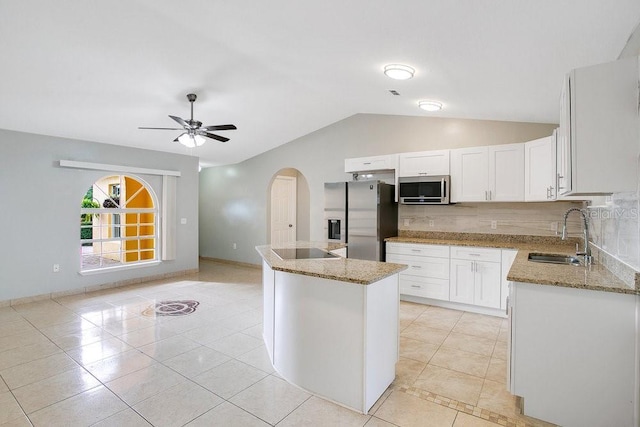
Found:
398,201 -> 586,238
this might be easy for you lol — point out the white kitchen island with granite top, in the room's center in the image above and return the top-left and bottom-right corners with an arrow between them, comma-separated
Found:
256,242 -> 406,413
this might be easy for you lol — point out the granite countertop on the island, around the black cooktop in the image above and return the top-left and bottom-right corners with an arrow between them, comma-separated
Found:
256,242 -> 407,285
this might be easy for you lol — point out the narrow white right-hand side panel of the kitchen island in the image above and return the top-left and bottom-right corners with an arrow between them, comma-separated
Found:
365,274 -> 400,411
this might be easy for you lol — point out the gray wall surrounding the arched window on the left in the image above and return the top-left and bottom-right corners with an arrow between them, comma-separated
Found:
0,130 -> 198,301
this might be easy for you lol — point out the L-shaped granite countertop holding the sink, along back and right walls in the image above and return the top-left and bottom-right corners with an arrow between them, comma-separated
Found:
386,232 -> 640,295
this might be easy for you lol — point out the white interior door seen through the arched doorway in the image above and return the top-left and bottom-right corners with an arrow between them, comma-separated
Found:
271,175 -> 297,246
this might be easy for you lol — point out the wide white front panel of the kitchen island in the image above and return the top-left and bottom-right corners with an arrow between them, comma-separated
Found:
274,271 -> 366,412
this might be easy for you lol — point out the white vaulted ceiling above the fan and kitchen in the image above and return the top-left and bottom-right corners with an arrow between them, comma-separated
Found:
0,0 -> 640,166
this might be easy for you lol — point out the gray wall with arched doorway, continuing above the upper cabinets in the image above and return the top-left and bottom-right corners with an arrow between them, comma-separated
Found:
200,114 -> 557,264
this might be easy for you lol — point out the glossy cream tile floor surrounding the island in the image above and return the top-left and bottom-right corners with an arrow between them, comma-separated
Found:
0,261 -> 546,427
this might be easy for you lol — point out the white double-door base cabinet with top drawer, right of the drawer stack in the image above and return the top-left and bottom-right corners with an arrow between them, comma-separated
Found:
449,246 -> 502,308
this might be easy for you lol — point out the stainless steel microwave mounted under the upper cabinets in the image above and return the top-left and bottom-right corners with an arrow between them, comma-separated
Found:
399,175 -> 451,205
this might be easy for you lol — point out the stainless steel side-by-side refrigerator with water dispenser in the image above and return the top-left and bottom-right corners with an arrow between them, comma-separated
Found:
324,181 -> 398,261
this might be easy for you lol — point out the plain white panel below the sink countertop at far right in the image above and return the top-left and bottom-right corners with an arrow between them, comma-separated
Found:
512,282 -> 637,426
